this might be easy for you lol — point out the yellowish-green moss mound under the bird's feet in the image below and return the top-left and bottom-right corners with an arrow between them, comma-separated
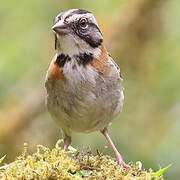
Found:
0,140 -> 166,180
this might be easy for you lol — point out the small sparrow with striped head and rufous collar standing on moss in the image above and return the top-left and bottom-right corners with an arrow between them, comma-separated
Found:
45,9 -> 130,168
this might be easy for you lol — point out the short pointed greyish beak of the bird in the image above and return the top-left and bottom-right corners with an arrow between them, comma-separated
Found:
52,21 -> 69,35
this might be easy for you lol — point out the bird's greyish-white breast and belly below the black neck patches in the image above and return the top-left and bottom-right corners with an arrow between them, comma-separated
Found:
46,52 -> 124,132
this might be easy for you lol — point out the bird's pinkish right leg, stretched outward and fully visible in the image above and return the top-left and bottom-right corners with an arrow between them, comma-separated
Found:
101,128 -> 131,168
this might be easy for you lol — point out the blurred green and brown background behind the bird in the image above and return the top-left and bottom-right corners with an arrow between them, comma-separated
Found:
0,0 -> 180,180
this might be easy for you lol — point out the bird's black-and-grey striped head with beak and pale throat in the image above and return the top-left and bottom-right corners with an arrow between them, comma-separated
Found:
52,9 -> 103,54
